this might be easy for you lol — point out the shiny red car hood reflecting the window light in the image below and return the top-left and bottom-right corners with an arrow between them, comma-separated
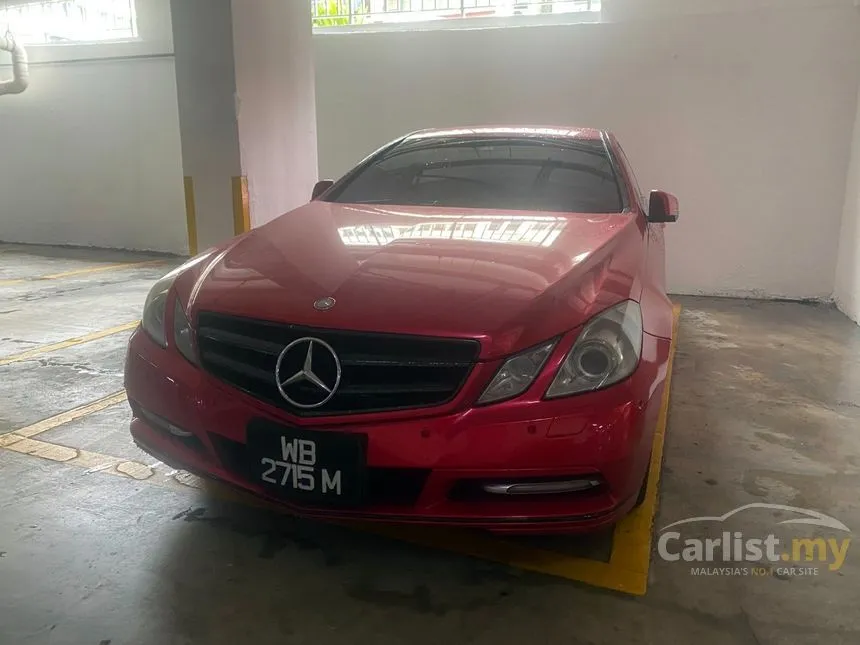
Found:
185,201 -> 643,359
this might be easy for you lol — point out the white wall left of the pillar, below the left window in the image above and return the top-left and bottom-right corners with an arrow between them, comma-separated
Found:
0,0 -> 187,253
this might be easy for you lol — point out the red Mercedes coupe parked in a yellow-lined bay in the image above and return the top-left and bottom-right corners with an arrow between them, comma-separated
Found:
125,128 -> 678,533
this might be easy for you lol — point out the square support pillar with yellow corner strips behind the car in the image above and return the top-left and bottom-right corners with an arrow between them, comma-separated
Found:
171,0 -> 317,253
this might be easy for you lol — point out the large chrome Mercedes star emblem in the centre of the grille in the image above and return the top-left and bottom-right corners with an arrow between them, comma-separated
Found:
275,336 -> 341,409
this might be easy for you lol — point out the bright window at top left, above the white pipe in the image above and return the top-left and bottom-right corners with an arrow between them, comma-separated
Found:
0,0 -> 137,45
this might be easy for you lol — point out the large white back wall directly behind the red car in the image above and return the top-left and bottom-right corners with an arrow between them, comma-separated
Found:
314,0 -> 860,298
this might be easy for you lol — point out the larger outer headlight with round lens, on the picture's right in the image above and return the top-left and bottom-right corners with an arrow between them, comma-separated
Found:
546,300 -> 642,398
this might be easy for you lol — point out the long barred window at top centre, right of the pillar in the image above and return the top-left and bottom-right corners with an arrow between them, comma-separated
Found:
311,0 -> 600,27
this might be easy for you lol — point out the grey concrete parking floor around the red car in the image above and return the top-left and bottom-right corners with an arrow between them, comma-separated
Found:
0,245 -> 860,645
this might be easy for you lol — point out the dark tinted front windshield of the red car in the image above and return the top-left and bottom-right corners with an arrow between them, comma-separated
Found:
326,136 -> 623,213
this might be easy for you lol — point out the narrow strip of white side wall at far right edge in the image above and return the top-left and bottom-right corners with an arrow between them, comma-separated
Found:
834,86 -> 860,323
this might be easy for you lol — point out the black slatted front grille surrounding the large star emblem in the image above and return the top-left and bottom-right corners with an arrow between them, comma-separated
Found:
197,312 -> 480,416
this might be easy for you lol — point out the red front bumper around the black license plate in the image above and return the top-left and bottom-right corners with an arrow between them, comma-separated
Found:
125,330 -> 669,533
